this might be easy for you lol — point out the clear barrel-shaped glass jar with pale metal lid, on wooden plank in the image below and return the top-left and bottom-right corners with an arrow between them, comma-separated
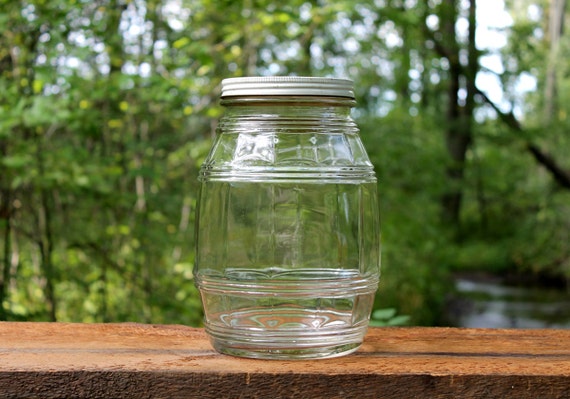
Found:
194,77 -> 380,359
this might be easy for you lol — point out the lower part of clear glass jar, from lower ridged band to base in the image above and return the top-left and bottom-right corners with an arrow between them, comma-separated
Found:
198,267 -> 378,359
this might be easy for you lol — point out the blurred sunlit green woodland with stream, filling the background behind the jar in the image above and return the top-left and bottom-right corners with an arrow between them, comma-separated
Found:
0,0 -> 570,328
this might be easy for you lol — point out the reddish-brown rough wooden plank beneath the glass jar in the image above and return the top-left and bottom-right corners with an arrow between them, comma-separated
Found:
0,322 -> 570,399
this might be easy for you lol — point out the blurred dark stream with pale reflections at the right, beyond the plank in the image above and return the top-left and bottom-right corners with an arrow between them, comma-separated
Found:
446,274 -> 570,329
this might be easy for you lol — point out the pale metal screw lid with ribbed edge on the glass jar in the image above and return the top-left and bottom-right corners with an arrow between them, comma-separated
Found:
222,76 -> 354,99
